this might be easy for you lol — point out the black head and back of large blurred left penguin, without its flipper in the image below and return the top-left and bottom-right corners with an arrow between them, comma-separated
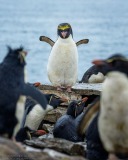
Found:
0,47 -> 26,138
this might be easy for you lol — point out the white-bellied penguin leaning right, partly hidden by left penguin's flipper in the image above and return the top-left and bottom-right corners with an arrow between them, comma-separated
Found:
21,94 -> 67,130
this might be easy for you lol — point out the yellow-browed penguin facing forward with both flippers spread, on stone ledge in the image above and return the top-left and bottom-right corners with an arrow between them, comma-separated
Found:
40,23 -> 89,92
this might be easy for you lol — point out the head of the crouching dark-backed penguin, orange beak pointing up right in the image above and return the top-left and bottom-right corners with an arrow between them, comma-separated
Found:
67,97 -> 88,118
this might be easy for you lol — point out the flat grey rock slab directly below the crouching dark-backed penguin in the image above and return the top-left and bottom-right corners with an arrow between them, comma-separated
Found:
25,138 -> 86,156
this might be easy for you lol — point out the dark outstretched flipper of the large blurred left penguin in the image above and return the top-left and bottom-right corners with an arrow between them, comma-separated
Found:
21,84 -> 48,109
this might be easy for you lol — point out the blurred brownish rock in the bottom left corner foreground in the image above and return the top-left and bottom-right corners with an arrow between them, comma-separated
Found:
0,137 -> 85,160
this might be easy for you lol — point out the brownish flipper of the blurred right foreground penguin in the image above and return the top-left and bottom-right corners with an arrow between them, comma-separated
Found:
78,96 -> 100,135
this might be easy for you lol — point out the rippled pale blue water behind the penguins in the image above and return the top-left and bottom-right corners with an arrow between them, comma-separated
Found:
0,0 -> 128,83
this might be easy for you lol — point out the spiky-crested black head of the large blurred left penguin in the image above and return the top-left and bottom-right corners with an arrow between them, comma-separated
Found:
3,46 -> 27,66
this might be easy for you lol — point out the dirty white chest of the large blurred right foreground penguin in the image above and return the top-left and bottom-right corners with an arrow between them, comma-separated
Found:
98,73 -> 128,152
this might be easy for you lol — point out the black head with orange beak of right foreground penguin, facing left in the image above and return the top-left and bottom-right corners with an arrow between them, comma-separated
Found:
92,53 -> 128,74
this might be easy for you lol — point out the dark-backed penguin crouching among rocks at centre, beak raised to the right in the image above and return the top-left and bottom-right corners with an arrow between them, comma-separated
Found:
53,97 -> 87,142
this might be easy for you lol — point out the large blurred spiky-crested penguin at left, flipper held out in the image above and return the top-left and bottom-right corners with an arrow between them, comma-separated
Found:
0,46 -> 47,138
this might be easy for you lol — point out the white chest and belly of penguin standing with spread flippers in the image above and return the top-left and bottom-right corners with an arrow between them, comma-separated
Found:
47,36 -> 78,86
